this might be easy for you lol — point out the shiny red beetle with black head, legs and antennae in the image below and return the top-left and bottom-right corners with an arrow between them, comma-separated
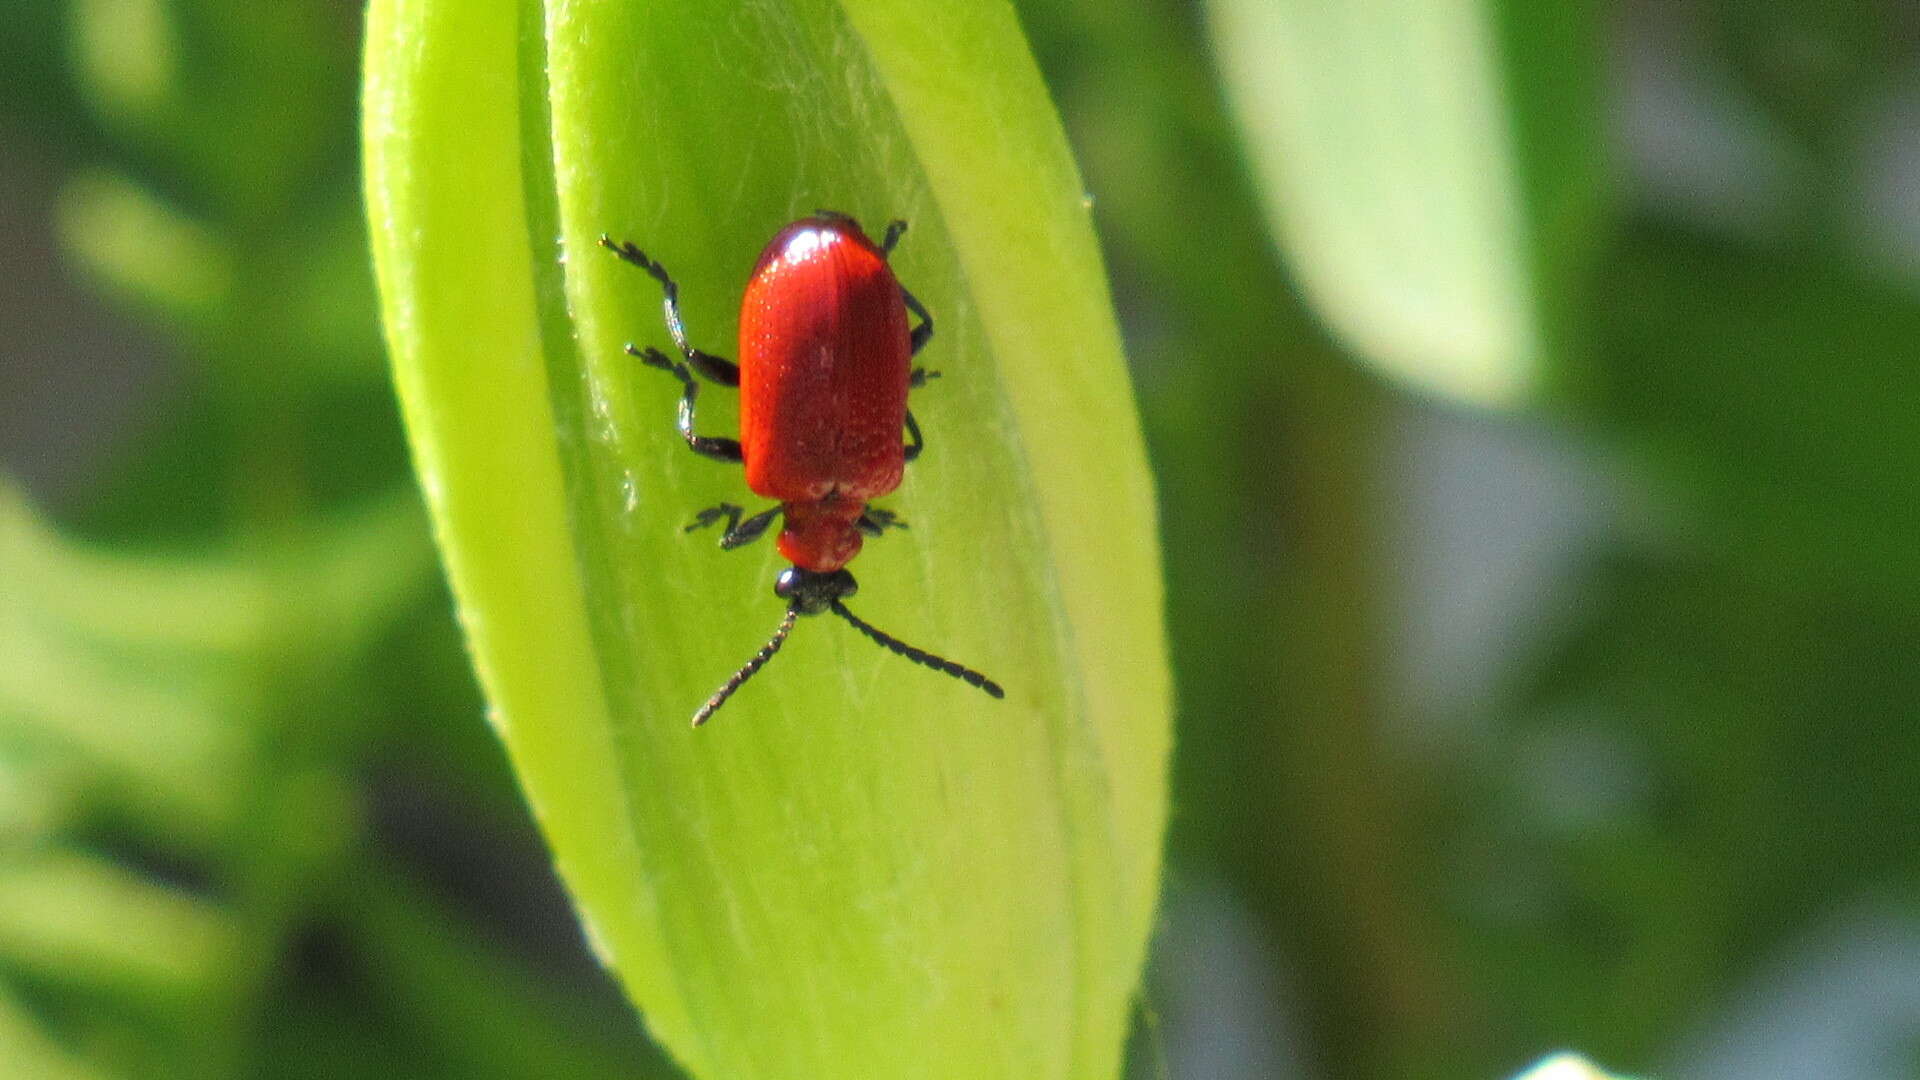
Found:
599,209 -> 1006,726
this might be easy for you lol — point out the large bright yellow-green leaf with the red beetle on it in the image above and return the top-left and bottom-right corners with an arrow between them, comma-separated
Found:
367,0 -> 1169,1078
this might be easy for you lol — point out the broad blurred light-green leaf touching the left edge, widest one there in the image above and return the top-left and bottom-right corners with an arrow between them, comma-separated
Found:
0,484 -> 430,846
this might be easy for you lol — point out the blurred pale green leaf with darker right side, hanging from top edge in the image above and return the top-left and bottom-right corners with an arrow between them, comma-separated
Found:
1210,0 -> 1601,405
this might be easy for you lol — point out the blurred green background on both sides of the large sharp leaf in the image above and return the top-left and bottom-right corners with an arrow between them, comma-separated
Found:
0,0 -> 1920,1080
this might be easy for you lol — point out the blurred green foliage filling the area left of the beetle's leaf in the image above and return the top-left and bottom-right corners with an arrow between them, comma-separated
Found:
0,0 -> 664,1080
